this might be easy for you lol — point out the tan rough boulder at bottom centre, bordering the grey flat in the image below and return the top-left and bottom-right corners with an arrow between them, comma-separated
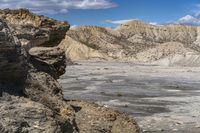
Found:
68,101 -> 139,133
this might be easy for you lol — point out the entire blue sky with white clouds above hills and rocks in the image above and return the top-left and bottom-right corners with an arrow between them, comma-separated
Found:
0,0 -> 200,27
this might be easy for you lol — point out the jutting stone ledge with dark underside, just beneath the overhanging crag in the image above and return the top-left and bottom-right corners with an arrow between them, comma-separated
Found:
29,47 -> 72,79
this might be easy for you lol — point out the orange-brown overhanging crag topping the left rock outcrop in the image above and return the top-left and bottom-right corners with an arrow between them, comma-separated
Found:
0,9 -> 70,50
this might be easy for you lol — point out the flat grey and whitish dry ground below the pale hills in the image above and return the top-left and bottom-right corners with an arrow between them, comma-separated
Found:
60,60 -> 200,133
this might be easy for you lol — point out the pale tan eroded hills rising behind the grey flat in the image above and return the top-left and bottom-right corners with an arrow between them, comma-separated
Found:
60,21 -> 200,65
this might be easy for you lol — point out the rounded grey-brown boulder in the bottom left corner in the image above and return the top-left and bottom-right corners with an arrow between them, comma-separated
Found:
0,96 -> 61,133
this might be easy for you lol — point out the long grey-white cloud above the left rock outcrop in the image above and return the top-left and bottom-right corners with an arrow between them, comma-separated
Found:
0,0 -> 117,14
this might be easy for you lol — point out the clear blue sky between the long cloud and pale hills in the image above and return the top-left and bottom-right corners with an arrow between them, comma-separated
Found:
56,0 -> 200,26
